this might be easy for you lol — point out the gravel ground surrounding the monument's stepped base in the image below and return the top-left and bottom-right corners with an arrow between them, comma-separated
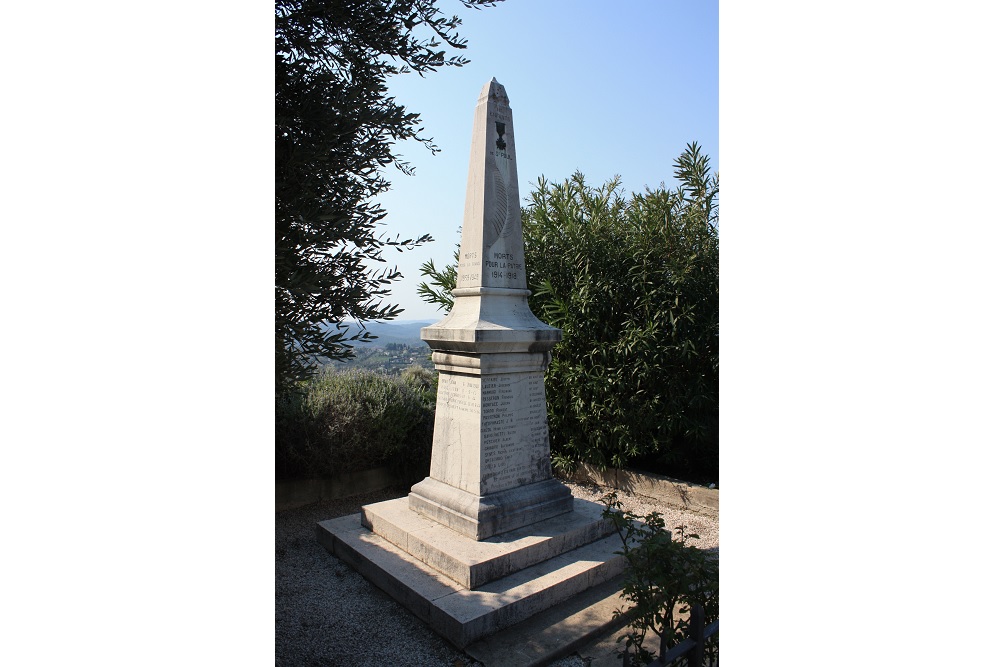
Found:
274,484 -> 719,667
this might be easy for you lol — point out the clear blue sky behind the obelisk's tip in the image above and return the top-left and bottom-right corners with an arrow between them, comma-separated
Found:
372,0 -> 719,320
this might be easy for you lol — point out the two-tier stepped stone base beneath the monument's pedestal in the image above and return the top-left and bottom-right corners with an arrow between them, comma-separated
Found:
316,498 -> 625,648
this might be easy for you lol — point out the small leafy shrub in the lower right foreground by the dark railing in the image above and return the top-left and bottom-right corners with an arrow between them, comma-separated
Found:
604,493 -> 719,665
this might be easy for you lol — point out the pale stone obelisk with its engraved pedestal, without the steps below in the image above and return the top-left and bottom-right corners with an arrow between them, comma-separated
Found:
410,79 -> 573,540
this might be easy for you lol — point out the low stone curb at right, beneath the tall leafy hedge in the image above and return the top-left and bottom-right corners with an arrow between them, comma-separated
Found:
570,464 -> 719,517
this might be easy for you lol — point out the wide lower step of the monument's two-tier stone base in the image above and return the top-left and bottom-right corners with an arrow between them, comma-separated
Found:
316,514 -> 624,648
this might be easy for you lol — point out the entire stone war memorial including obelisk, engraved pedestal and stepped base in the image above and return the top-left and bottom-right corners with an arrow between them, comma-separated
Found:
317,79 -> 624,647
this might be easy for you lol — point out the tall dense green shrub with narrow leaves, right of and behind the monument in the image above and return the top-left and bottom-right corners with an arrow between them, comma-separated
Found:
421,143 -> 719,481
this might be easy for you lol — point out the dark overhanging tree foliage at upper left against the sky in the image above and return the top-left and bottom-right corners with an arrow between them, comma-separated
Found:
275,0 -> 495,391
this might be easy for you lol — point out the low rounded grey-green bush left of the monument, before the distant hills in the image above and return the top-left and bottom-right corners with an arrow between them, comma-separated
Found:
275,370 -> 434,482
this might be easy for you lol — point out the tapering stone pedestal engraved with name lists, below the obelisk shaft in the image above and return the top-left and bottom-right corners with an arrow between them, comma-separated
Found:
410,340 -> 573,540
